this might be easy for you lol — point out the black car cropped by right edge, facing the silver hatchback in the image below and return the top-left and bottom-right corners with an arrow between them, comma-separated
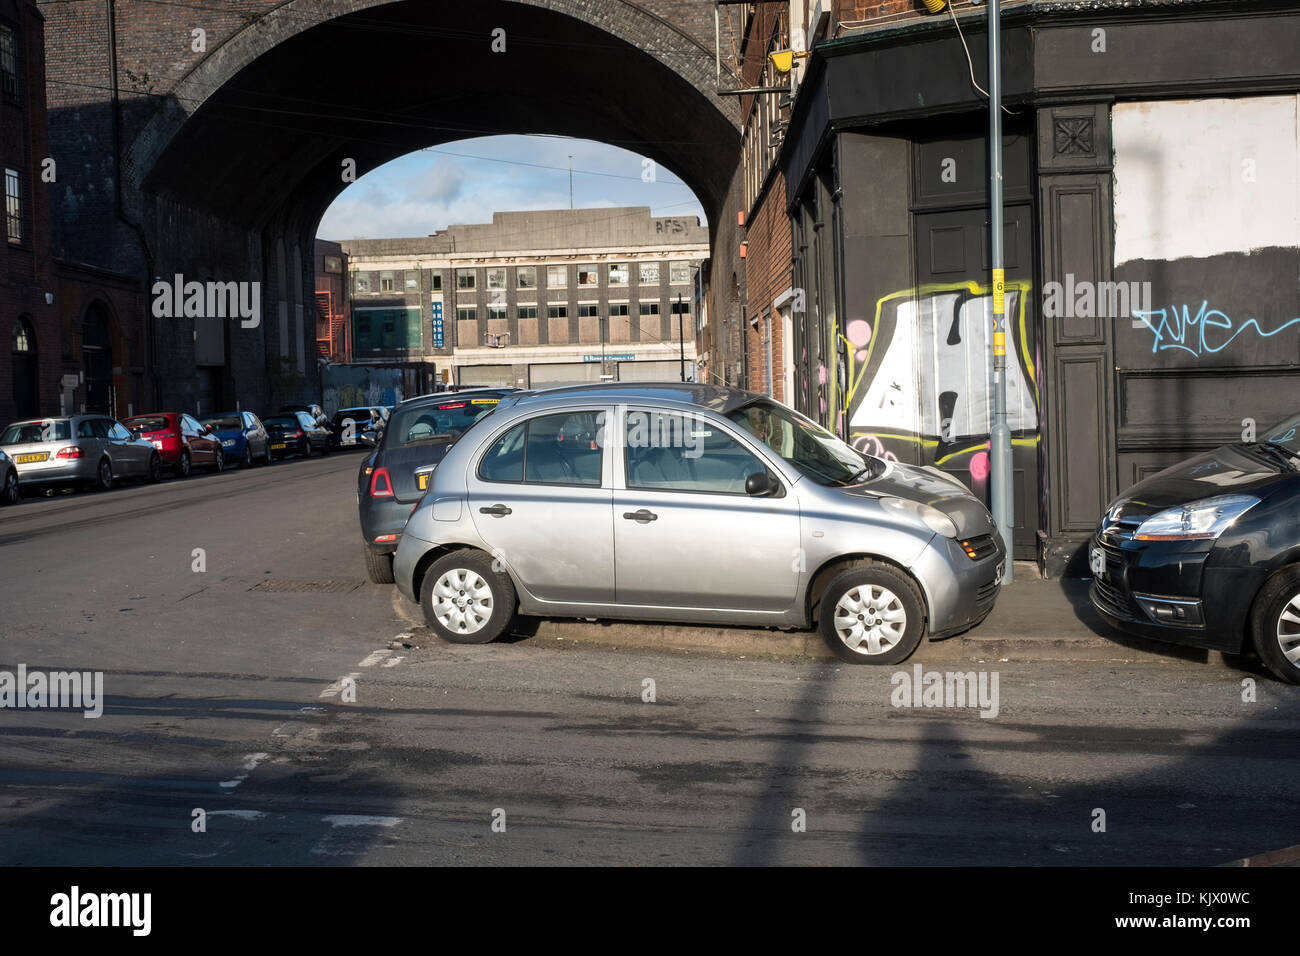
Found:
1089,415 -> 1300,684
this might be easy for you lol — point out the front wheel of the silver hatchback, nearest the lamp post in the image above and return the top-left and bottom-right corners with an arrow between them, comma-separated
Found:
818,564 -> 926,663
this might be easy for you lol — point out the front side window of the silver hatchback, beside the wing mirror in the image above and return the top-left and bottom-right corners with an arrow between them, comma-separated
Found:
624,408 -> 766,494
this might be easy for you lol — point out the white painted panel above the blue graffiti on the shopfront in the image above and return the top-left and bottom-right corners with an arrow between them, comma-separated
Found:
1112,95 -> 1300,265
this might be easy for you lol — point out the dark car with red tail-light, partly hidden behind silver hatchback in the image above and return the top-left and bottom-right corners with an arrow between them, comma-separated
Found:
356,389 -> 515,584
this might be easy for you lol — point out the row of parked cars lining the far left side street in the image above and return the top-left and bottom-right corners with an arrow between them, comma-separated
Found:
0,405 -> 386,503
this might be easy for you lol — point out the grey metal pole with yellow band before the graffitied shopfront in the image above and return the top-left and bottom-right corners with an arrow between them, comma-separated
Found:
988,0 -> 1015,584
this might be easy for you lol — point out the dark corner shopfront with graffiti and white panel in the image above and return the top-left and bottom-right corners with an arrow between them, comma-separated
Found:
781,3 -> 1300,575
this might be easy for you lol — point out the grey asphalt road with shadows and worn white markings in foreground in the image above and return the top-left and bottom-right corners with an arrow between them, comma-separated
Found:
0,455 -> 1300,865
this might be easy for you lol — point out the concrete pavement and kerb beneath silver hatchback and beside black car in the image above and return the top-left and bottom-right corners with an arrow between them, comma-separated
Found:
504,562 -> 1240,667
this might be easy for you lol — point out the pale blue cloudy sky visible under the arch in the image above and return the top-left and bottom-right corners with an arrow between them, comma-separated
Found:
317,135 -> 706,242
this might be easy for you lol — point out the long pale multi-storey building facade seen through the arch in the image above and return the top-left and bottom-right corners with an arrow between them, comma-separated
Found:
339,207 -> 709,388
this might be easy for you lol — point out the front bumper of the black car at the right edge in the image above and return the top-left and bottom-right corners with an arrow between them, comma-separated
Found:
1088,531 -> 1266,653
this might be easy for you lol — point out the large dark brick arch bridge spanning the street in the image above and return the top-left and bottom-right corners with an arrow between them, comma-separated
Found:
44,0 -> 740,406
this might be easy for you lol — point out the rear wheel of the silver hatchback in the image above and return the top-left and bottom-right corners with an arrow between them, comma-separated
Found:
420,549 -> 515,644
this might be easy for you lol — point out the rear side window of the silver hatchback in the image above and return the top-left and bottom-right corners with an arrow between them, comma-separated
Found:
478,411 -> 605,488
